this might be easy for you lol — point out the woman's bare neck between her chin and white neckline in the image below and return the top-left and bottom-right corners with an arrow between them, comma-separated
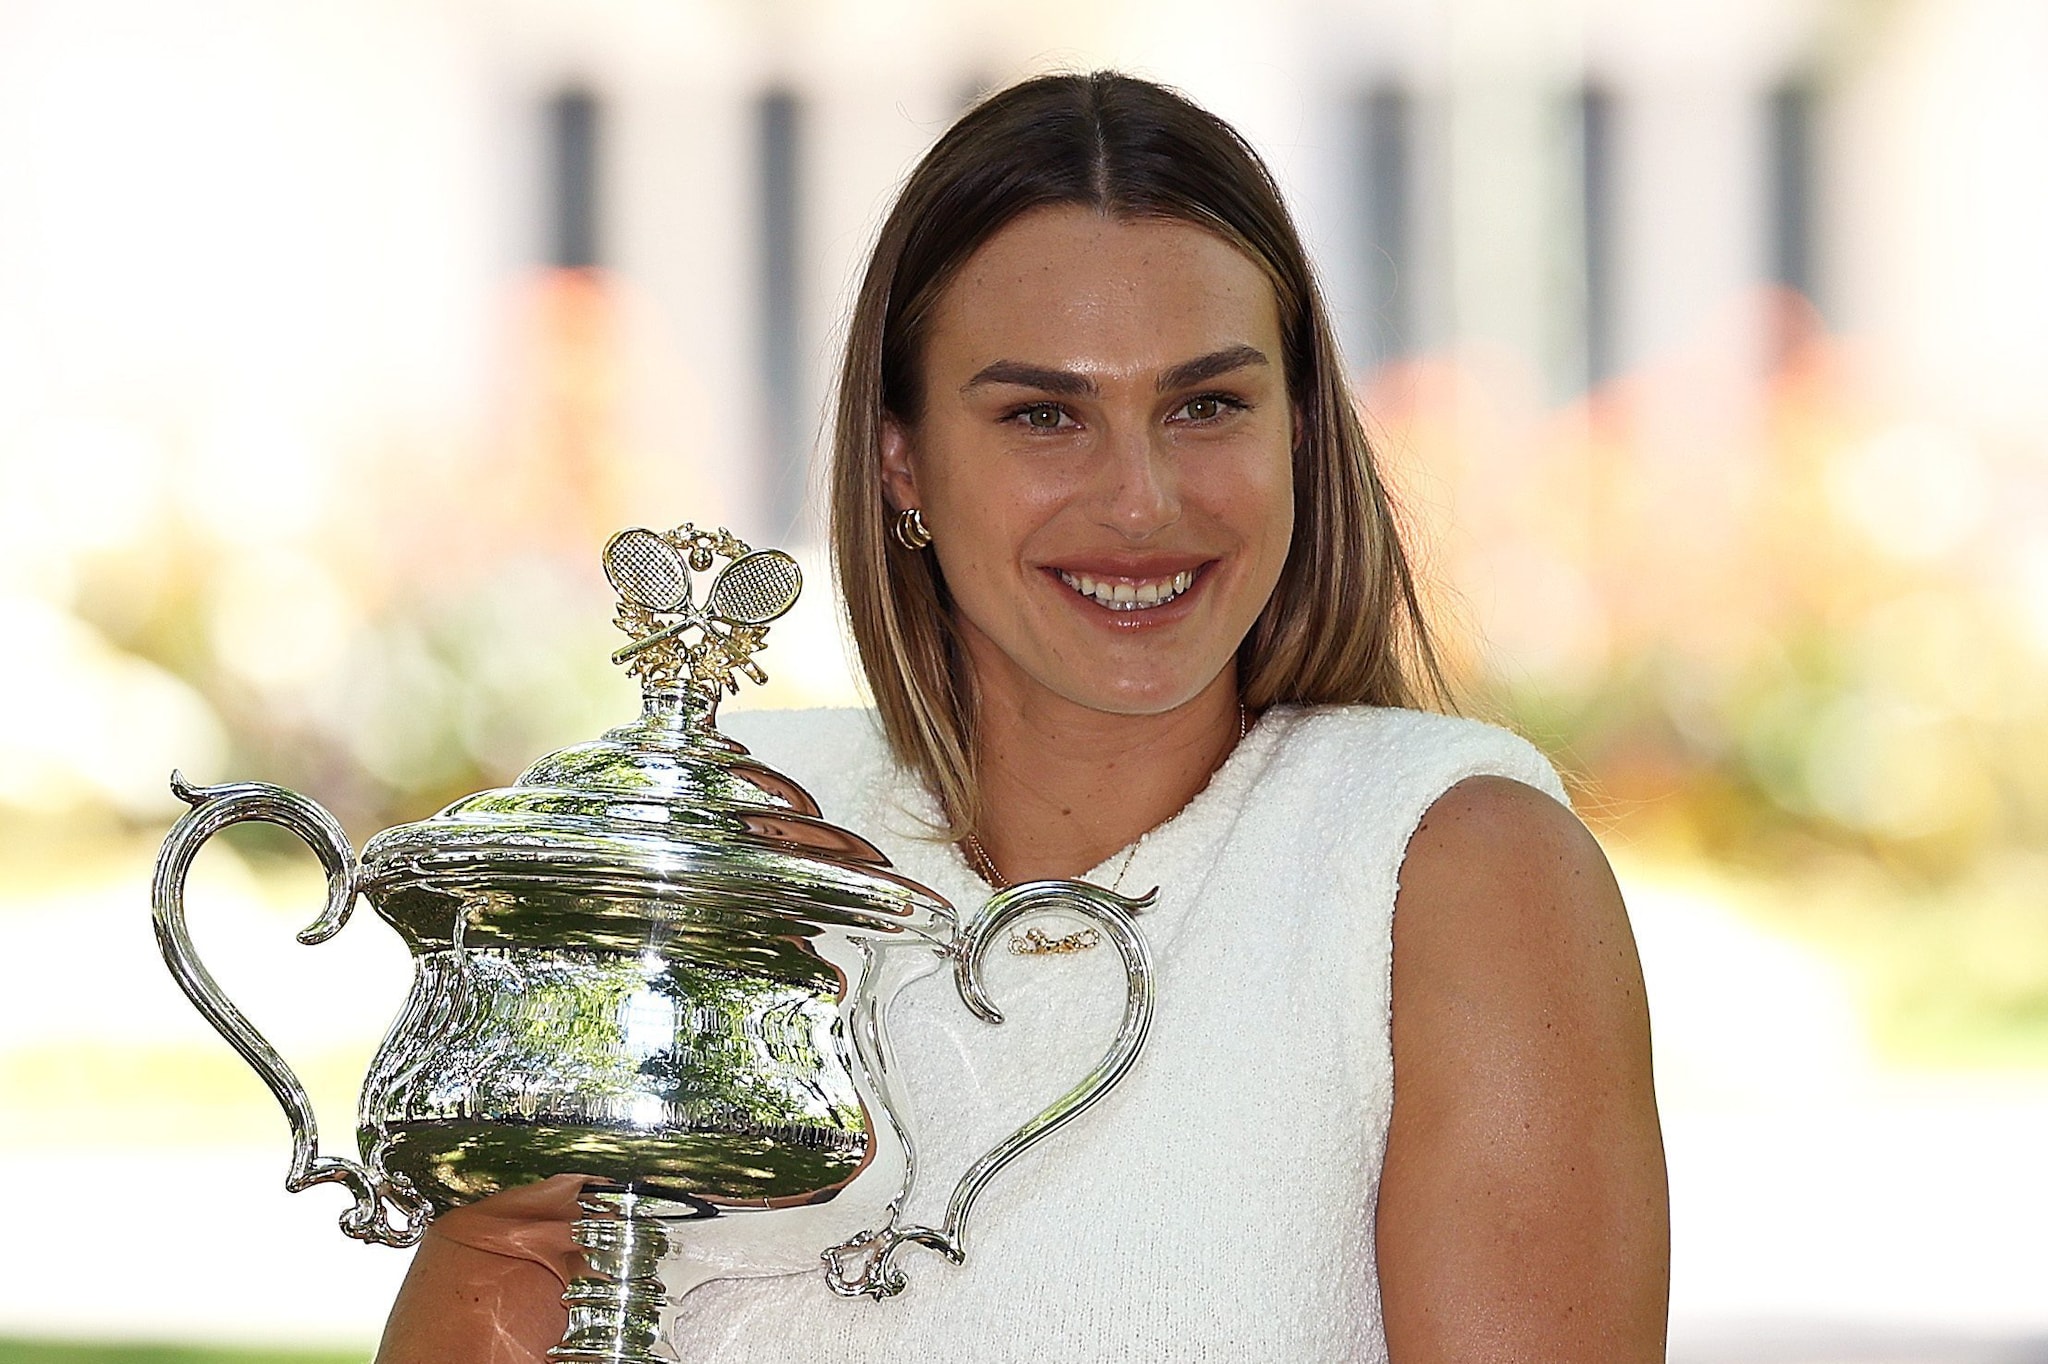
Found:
975,668 -> 1241,883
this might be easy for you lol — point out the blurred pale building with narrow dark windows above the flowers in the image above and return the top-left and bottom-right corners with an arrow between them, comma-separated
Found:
0,0 -> 2048,552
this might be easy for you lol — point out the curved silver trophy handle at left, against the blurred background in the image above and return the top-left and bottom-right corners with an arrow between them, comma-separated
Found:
152,772 -> 432,1245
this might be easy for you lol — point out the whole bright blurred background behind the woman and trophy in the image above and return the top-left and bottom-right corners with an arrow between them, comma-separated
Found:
0,0 -> 2048,1364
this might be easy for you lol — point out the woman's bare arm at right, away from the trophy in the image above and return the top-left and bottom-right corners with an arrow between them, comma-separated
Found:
1376,776 -> 1671,1364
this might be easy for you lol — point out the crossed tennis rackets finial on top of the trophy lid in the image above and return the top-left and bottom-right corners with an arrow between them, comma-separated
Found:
604,522 -> 803,696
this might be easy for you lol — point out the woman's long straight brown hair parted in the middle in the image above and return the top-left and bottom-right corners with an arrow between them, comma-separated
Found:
831,72 -> 1448,836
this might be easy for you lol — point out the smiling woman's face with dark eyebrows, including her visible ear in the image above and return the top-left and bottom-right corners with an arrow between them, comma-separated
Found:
883,207 -> 1294,715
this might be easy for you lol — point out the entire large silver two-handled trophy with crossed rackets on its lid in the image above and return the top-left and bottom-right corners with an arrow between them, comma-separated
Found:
154,524 -> 1153,1364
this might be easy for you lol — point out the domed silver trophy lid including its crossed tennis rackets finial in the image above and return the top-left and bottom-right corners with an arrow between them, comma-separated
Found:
362,524 -> 954,950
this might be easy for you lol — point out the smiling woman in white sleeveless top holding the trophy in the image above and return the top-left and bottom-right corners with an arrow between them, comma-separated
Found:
383,74 -> 1669,1364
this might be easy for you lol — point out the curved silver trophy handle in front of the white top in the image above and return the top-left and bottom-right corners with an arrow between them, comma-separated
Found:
825,881 -> 1157,1301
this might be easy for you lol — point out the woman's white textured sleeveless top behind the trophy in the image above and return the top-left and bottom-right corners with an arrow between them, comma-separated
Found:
670,707 -> 1565,1364
